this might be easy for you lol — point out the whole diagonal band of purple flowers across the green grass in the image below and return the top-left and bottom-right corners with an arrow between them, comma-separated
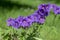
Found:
7,4 -> 60,28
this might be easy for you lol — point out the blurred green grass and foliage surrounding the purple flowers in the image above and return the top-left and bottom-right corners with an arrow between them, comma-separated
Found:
0,0 -> 60,40
